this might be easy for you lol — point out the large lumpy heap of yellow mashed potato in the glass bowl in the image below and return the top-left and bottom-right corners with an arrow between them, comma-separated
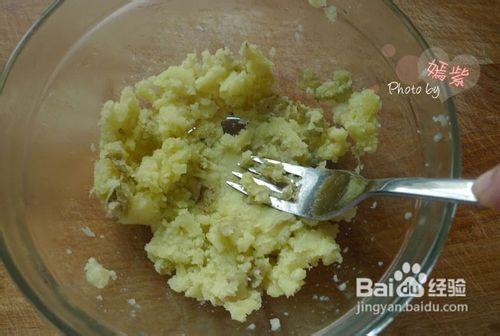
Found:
92,43 -> 380,321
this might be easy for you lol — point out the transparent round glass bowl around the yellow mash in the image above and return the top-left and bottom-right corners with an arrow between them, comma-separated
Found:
0,0 -> 460,335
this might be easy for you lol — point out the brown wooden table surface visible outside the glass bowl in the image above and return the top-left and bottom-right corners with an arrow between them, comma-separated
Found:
0,0 -> 500,335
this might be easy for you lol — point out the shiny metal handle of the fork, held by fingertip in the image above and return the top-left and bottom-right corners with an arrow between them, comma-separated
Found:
372,177 -> 478,204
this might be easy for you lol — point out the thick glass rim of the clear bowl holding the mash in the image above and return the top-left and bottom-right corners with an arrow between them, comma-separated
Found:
0,0 -> 461,335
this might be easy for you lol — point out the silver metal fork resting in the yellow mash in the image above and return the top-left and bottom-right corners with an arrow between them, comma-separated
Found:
226,156 -> 477,220
